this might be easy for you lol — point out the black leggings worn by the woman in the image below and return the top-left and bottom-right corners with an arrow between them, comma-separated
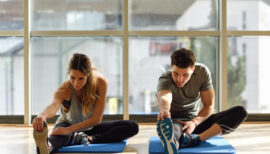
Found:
48,120 -> 139,152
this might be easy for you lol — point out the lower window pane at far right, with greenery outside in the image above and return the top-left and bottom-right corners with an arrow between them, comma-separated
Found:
227,37 -> 270,113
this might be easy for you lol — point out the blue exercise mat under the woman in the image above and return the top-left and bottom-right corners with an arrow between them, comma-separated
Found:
55,140 -> 127,153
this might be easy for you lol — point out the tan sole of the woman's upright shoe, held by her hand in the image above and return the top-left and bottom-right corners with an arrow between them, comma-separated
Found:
33,122 -> 50,154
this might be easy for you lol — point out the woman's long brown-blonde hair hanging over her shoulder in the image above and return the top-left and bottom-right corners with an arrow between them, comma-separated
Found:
68,53 -> 99,117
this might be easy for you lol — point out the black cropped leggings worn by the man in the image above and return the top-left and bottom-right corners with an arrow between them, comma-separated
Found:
173,106 -> 247,141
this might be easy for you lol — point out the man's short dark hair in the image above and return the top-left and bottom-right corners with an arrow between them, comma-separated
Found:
171,48 -> 196,68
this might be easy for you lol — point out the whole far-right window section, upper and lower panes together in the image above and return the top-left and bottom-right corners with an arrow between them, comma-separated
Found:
227,0 -> 270,113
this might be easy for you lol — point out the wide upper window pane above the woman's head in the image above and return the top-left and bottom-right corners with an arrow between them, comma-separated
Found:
31,0 -> 123,30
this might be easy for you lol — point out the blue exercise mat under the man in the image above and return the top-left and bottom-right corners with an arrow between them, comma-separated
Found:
149,136 -> 236,154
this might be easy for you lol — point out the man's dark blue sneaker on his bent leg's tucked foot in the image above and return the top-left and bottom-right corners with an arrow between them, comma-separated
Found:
180,133 -> 202,148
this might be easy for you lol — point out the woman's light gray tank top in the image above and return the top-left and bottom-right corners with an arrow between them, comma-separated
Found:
55,82 -> 94,126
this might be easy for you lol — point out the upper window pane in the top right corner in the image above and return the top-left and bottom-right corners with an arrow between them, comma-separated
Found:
227,0 -> 270,30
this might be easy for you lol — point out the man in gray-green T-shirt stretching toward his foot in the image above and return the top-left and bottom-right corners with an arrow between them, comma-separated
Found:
157,48 -> 247,154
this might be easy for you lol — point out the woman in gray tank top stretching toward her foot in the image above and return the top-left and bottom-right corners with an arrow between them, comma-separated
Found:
33,53 -> 138,154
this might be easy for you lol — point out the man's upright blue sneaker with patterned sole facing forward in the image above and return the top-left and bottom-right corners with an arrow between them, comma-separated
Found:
157,118 -> 178,154
